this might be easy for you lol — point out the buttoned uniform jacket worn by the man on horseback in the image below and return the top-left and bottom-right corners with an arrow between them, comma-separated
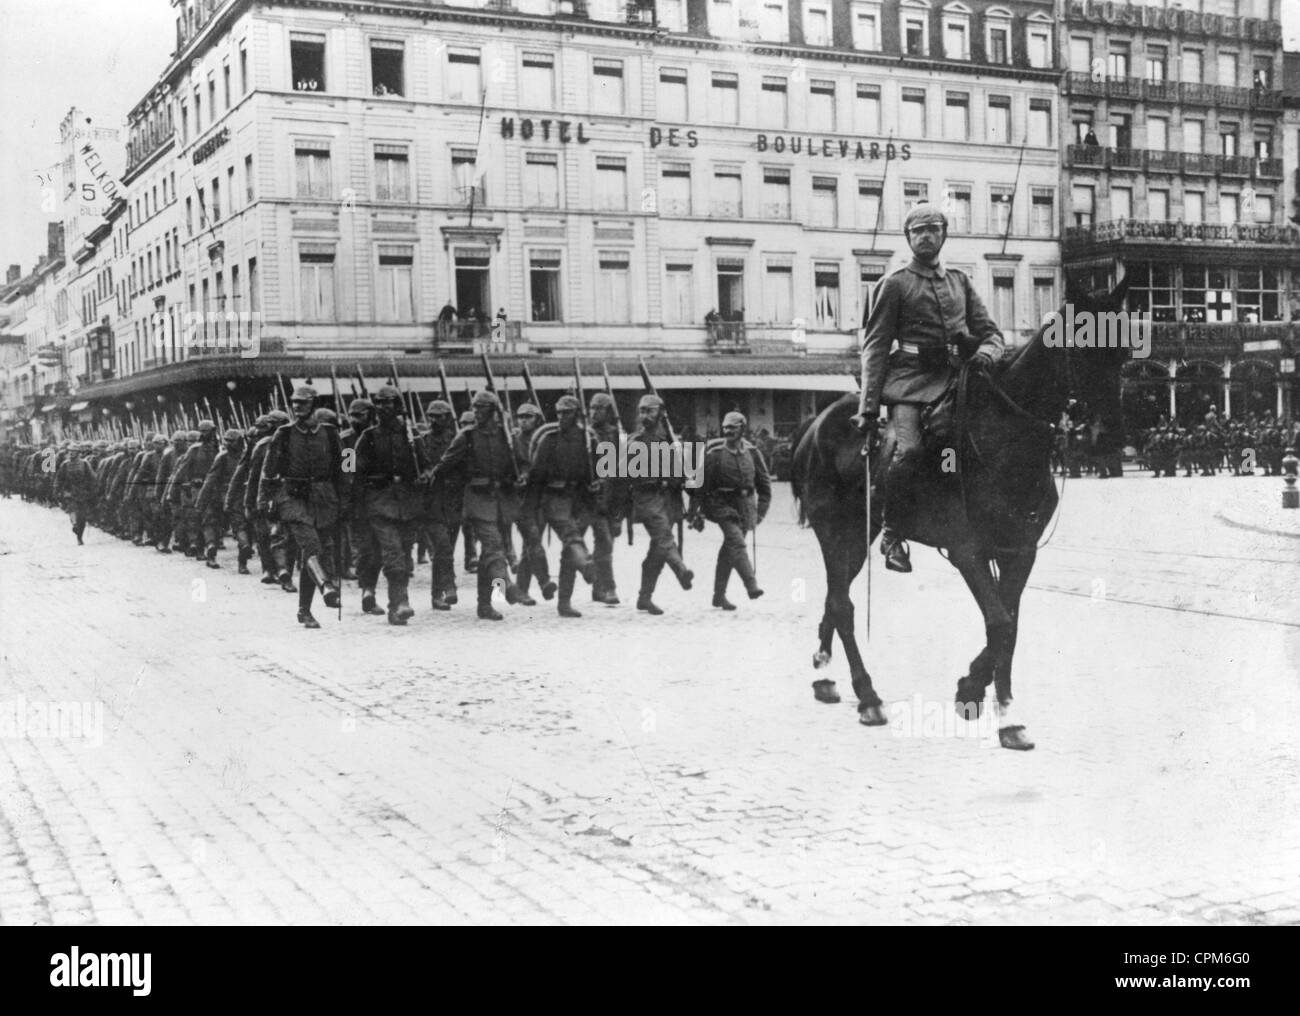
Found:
862,259 -> 1006,417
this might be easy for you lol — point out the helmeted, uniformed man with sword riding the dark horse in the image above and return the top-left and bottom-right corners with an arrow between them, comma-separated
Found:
853,204 -> 1006,572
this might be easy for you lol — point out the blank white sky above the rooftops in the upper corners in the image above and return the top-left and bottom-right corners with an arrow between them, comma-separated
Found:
0,0 -> 1300,278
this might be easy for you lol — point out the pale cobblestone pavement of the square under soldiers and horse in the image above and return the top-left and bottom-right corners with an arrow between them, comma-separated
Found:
0,476 -> 1300,924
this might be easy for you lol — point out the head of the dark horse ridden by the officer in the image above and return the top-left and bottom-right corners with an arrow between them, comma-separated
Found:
1053,279 -> 1138,455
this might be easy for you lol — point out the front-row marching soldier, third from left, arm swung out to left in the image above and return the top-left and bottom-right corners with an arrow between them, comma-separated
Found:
426,391 -> 528,621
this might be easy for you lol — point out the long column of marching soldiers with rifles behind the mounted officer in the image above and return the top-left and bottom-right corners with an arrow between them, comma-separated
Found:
0,385 -> 771,628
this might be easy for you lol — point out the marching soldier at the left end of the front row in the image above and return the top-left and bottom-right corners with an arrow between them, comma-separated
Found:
257,386 -> 343,628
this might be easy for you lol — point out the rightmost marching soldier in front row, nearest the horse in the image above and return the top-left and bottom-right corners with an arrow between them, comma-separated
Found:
690,413 -> 772,611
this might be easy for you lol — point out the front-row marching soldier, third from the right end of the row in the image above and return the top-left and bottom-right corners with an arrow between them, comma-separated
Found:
520,395 -> 597,617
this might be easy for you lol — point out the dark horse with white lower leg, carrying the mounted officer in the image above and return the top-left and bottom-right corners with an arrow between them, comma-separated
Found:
790,282 -> 1128,751
